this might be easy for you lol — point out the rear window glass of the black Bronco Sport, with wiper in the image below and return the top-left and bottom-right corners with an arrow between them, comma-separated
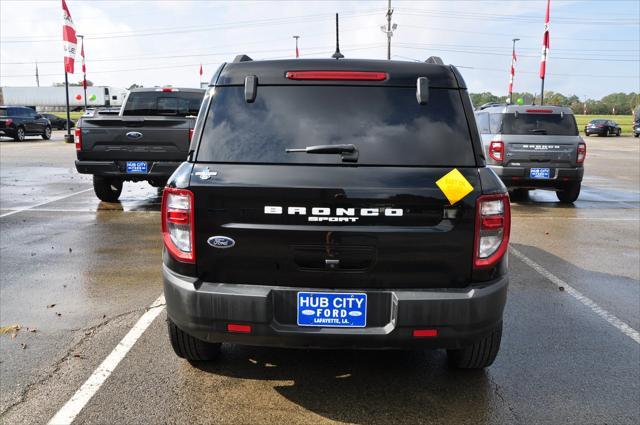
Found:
197,86 -> 475,166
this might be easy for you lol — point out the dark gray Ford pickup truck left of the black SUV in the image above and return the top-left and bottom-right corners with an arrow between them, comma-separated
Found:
75,87 -> 204,202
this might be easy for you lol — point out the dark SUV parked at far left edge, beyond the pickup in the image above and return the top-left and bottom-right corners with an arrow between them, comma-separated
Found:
0,106 -> 51,142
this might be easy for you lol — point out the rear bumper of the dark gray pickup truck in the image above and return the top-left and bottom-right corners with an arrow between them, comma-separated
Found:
76,160 -> 182,181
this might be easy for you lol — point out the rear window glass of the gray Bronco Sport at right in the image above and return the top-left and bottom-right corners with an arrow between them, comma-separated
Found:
490,113 -> 578,136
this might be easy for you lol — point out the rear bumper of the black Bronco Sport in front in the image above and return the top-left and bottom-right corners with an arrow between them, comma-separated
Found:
163,265 -> 509,348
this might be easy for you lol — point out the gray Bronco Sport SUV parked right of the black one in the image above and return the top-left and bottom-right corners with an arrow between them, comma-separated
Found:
475,104 -> 587,203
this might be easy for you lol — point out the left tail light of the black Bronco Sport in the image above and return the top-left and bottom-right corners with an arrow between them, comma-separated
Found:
162,187 -> 196,263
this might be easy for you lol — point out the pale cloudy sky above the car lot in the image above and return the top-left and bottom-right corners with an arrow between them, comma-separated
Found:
0,0 -> 640,98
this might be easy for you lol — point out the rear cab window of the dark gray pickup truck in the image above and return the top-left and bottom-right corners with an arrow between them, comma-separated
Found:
122,92 -> 204,117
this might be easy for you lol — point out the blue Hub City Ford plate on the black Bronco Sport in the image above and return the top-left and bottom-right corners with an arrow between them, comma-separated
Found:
298,292 -> 367,328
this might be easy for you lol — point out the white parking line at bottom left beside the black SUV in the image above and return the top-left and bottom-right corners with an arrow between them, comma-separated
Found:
49,294 -> 165,425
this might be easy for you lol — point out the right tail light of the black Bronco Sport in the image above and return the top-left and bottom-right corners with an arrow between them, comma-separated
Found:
473,193 -> 511,268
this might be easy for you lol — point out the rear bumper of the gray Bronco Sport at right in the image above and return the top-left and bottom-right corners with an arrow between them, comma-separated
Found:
490,165 -> 584,189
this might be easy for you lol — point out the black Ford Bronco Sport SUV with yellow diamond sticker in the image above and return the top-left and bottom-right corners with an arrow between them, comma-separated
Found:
162,56 -> 510,368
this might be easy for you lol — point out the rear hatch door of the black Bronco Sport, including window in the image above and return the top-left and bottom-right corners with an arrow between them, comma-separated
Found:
190,80 -> 480,288
